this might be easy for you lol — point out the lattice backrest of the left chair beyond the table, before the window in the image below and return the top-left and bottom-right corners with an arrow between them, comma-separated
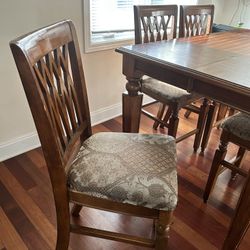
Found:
134,5 -> 178,44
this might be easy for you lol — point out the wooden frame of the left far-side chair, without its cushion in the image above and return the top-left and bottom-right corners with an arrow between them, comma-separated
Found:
134,5 -> 208,152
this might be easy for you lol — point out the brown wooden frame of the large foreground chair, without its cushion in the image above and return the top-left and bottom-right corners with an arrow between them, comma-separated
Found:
10,20 -> 172,250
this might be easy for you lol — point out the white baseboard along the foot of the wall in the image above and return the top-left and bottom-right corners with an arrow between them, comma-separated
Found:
0,96 -> 154,162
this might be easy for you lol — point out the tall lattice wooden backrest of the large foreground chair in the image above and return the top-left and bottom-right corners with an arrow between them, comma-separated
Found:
10,21 -> 91,179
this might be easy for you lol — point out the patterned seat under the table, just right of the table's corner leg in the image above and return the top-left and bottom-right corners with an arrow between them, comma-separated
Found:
141,78 -> 201,107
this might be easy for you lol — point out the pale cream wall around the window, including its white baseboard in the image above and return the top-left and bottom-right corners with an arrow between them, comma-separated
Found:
0,0 -> 250,161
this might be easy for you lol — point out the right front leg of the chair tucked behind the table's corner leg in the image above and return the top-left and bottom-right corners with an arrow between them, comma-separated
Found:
193,98 -> 208,152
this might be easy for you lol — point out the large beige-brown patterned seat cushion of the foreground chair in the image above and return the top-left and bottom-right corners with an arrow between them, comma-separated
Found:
68,132 -> 177,211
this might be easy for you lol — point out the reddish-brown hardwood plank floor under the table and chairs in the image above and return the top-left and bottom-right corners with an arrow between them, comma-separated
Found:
0,106 -> 250,250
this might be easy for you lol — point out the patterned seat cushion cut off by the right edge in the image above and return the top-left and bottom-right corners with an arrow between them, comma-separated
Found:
221,113 -> 250,141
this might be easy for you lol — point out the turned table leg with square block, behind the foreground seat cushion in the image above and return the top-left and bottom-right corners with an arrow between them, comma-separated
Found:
122,78 -> 143,133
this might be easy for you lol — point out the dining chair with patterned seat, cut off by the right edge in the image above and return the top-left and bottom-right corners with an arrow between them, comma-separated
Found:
203,113 -> 250,202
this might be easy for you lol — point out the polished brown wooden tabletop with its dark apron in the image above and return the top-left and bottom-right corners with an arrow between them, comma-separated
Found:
116,29 -> 250,115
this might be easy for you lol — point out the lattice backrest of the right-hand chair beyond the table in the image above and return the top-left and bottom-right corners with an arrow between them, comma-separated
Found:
179,5 -> 214,37
